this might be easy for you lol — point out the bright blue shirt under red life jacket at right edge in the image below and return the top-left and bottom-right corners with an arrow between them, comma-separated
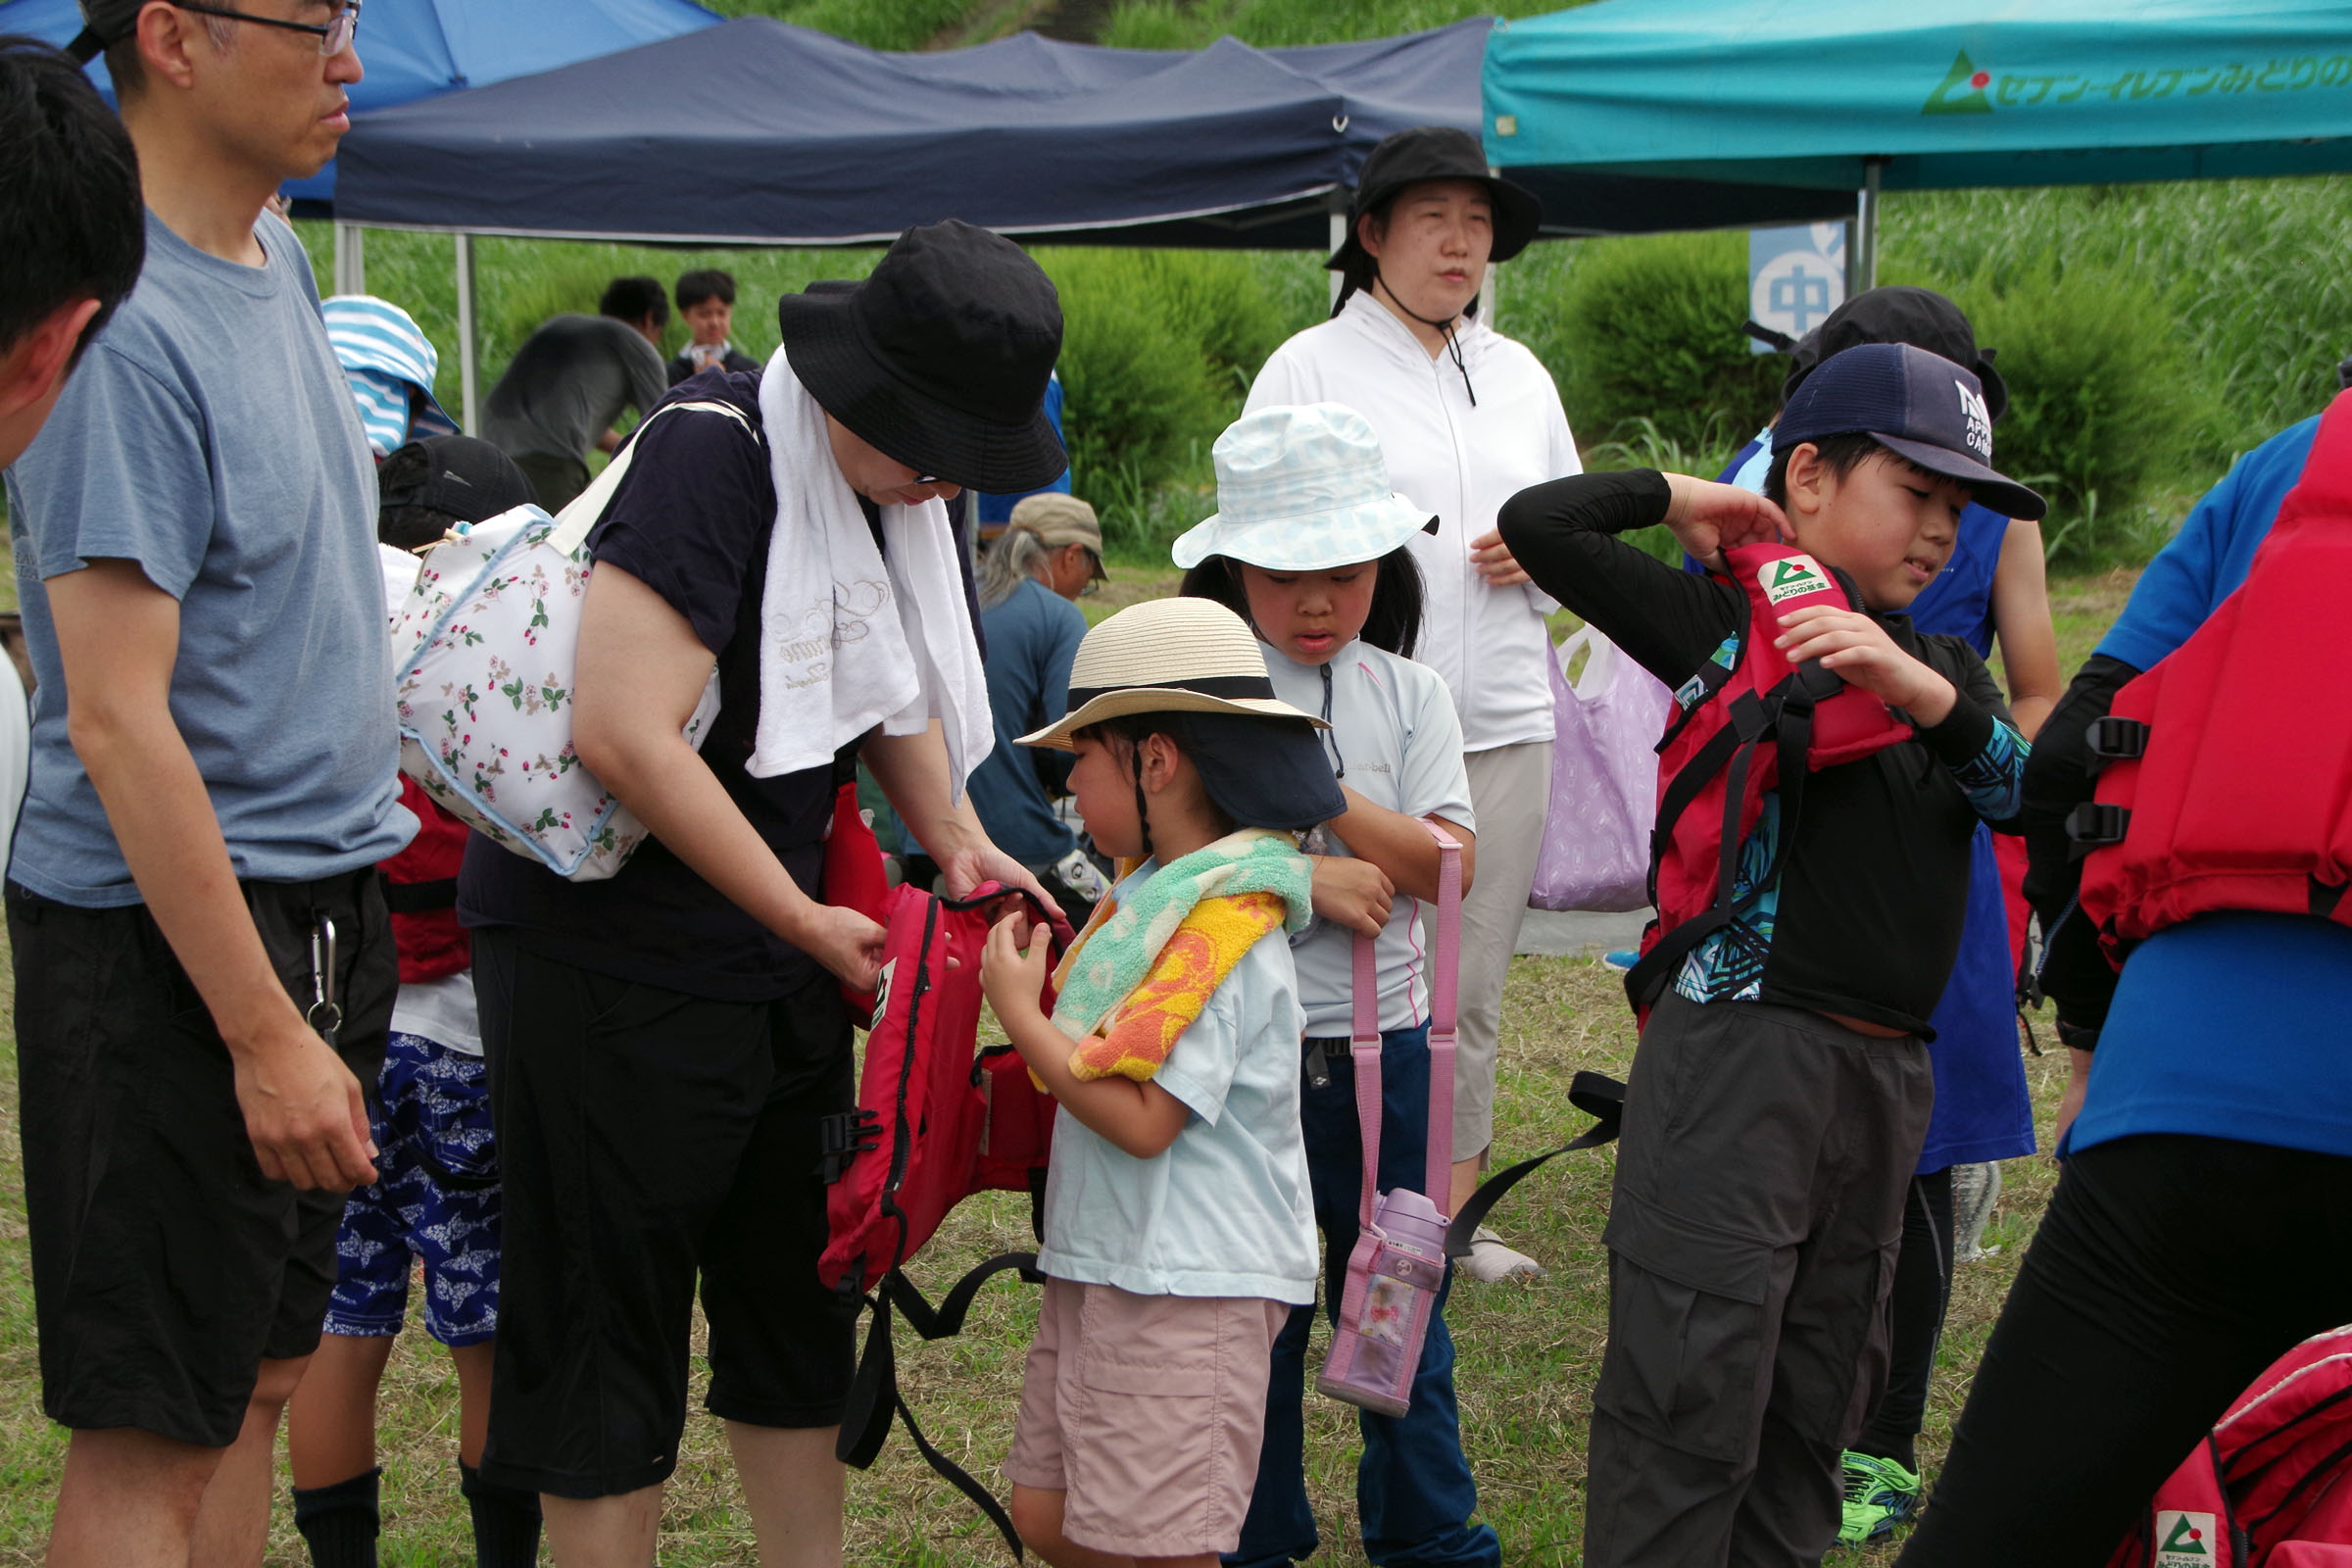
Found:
2068,418 -> 2352,1154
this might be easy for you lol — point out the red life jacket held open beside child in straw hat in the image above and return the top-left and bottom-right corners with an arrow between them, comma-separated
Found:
818,882 -> 1075,1556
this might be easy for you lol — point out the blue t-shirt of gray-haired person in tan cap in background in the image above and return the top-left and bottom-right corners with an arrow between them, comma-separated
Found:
964,578 -> 1087,865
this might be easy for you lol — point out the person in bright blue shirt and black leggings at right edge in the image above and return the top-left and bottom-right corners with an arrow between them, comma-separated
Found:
1898,380 -> 2352,1568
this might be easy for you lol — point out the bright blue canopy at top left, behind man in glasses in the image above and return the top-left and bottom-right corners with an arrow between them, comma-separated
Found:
0,0 -> 717,217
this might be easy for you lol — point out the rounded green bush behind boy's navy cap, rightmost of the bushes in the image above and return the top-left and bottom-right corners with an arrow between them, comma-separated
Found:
1952,266 -> 2204,564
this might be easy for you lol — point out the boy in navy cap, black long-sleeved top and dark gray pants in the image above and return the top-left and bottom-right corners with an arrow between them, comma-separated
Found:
1500,343 -> 2044,1568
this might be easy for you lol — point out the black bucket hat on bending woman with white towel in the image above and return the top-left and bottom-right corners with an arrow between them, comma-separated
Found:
776,219 -> 1070,494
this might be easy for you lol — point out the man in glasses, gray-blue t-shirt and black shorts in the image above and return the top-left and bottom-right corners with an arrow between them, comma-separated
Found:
7,0 -> 416,1566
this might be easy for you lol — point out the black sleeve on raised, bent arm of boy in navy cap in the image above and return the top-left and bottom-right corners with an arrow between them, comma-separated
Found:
1498,467 -> 1740,686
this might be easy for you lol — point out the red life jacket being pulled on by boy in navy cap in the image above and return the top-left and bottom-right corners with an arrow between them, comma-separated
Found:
1625,546 -> 1912,1015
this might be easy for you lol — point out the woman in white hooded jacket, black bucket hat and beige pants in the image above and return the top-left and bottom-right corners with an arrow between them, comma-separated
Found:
1249,124 -> 1583,1279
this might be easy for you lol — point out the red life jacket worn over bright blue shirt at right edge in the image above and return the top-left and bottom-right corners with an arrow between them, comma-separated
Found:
2068,393 -> 2352,961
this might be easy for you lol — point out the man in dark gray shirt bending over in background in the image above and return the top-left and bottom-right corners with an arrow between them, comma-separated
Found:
482,277 -> 670,513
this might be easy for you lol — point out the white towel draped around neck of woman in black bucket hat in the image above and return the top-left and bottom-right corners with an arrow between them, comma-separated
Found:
748,348 -> 995,800
